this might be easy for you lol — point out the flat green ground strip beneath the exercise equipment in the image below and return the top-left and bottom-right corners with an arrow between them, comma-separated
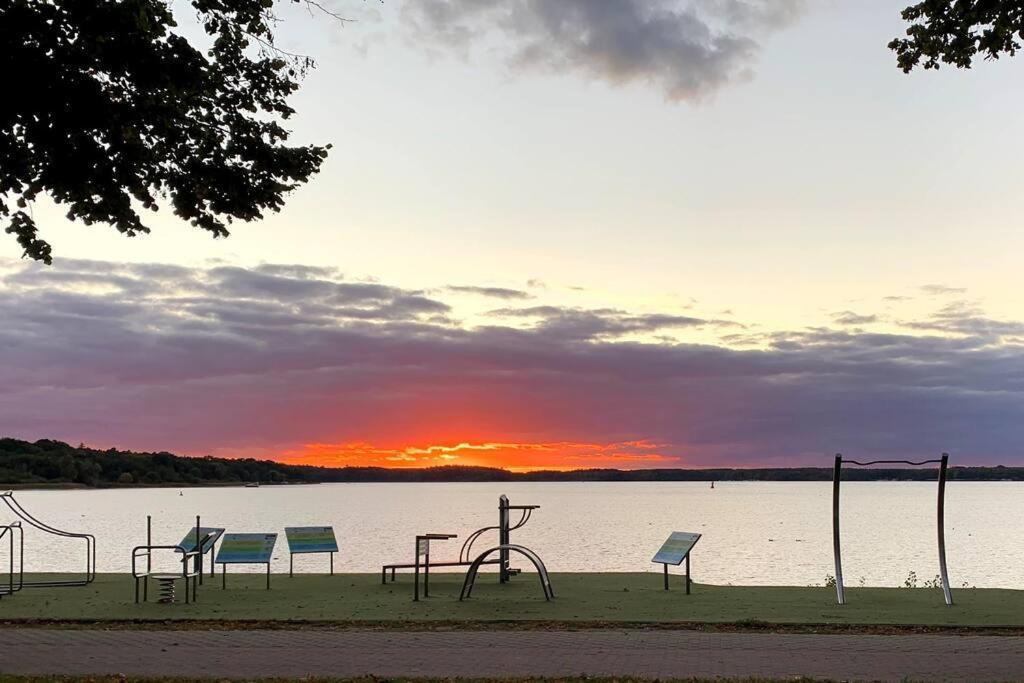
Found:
0,573 -> 1024,629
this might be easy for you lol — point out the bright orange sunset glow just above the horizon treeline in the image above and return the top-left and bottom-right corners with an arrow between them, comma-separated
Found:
278,440 -> 680,472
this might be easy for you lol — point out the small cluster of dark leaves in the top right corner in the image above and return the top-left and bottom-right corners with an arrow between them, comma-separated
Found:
889,0 -> 1024,72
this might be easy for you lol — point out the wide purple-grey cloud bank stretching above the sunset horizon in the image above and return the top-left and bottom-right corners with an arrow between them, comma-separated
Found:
0,263 -> 1024,465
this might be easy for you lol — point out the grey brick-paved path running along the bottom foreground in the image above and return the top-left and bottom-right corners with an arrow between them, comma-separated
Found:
0,628 -> 1024,681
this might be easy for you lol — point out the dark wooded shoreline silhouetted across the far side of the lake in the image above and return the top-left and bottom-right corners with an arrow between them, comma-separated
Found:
0,438 -> 1024,486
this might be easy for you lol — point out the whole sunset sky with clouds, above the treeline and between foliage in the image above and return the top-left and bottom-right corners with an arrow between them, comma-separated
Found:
0,0 -> 1024,469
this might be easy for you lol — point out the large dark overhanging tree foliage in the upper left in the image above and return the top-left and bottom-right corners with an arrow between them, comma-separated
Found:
0,0 -> 330,263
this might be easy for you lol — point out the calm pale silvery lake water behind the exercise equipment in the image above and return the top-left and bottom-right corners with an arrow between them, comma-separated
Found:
0,482 -> 1024,588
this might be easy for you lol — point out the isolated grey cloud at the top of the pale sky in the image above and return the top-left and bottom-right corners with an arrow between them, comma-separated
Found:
402,0 -> 806,100
